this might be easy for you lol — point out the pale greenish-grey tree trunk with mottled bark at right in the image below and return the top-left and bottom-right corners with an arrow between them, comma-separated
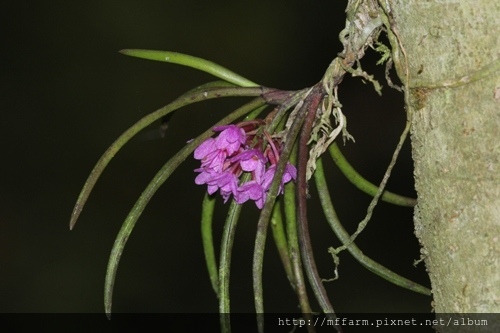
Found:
388,0 -> 500,326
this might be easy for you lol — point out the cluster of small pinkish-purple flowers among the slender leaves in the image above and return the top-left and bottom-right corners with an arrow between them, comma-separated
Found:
194,122 -> 297,209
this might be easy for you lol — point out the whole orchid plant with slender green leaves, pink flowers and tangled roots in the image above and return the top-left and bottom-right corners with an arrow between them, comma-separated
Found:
70,1 -> 430,332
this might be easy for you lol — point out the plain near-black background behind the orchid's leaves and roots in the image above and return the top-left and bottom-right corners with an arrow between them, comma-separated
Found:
0,0 -> 431,313
